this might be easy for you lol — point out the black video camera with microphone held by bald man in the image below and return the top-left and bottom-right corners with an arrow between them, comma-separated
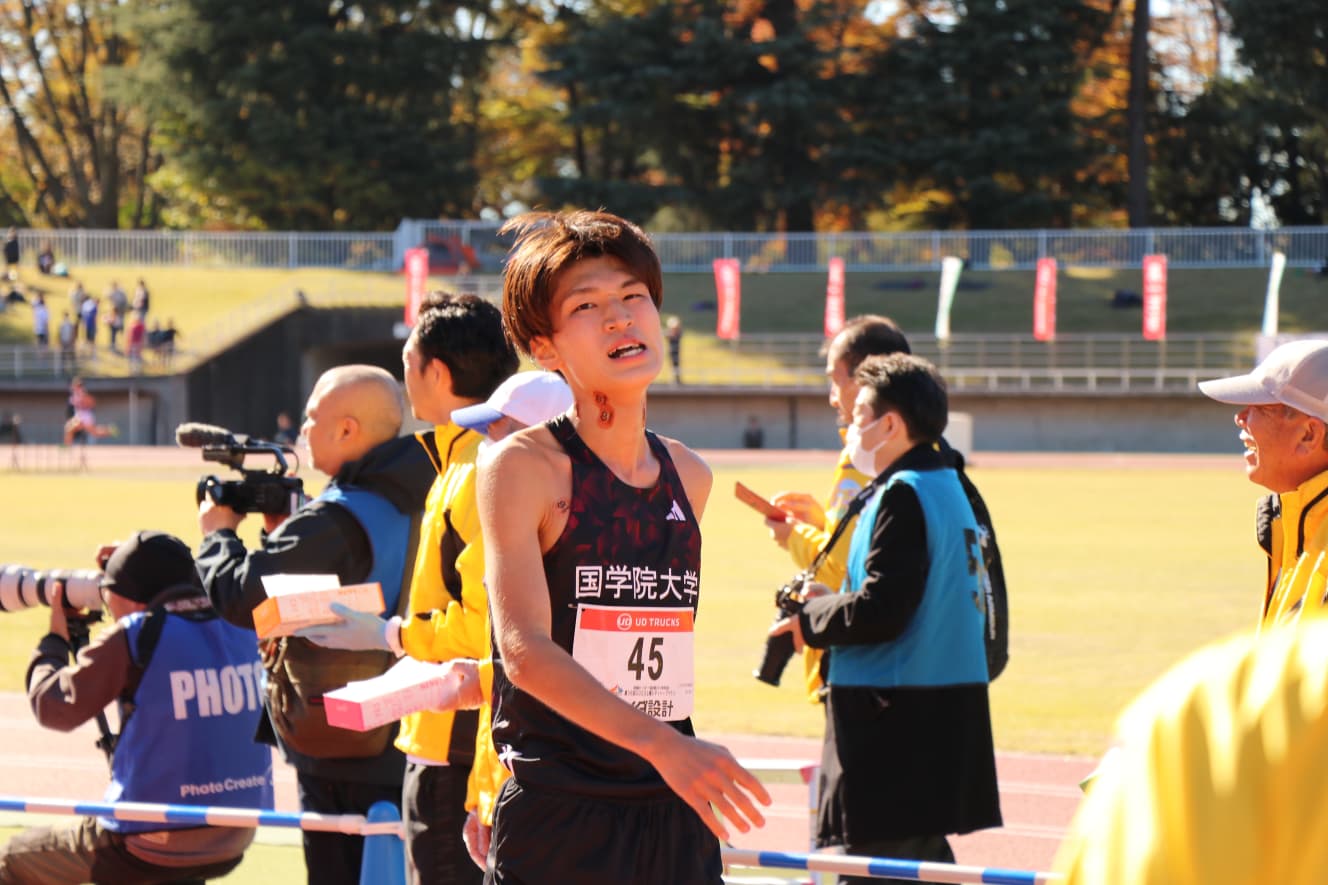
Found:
175,423 -> 305,516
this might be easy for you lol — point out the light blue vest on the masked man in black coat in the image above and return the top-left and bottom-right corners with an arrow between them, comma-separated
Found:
830,469 -> 987,688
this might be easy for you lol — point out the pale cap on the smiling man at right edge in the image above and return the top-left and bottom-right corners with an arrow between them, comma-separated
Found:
1199,340 -> 1328,421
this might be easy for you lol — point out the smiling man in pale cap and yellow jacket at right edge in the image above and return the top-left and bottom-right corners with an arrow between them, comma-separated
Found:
1199,334 -> 1328,626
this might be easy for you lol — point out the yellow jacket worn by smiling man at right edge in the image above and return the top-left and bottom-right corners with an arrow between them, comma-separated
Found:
1263,472 -> 1328,629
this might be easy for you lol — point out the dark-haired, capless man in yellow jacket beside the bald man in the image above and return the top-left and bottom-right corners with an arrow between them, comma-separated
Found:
300,292 -> 518,884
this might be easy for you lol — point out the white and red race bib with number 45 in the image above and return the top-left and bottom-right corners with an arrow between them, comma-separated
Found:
572,606 -> 693,720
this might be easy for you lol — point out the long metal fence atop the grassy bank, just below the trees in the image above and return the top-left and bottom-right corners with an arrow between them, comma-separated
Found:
10,219 -> 1328,274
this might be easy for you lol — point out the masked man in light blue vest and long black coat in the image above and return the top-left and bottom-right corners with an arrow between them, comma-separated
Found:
770,353 -> 1001,884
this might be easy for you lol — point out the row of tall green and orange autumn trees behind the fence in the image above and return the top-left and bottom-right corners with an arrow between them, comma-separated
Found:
0,0 -> 1328,231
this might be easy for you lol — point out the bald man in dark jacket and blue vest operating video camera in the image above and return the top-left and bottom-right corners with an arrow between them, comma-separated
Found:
197,365 -> 436,885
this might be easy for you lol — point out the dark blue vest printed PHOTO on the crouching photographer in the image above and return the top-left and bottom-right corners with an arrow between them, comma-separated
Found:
100,611 -> 272,833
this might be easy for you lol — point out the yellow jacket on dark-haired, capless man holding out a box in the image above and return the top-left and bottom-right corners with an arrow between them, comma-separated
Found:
397,424 -> 489,761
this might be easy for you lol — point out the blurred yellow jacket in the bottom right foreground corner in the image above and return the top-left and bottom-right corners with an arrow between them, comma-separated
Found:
1056,618 -> 1328,885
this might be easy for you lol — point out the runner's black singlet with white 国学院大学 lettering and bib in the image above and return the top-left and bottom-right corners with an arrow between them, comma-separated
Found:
493,416 -> 701,796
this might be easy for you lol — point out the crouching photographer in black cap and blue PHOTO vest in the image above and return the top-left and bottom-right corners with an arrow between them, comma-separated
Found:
0,532 -> 272,885
